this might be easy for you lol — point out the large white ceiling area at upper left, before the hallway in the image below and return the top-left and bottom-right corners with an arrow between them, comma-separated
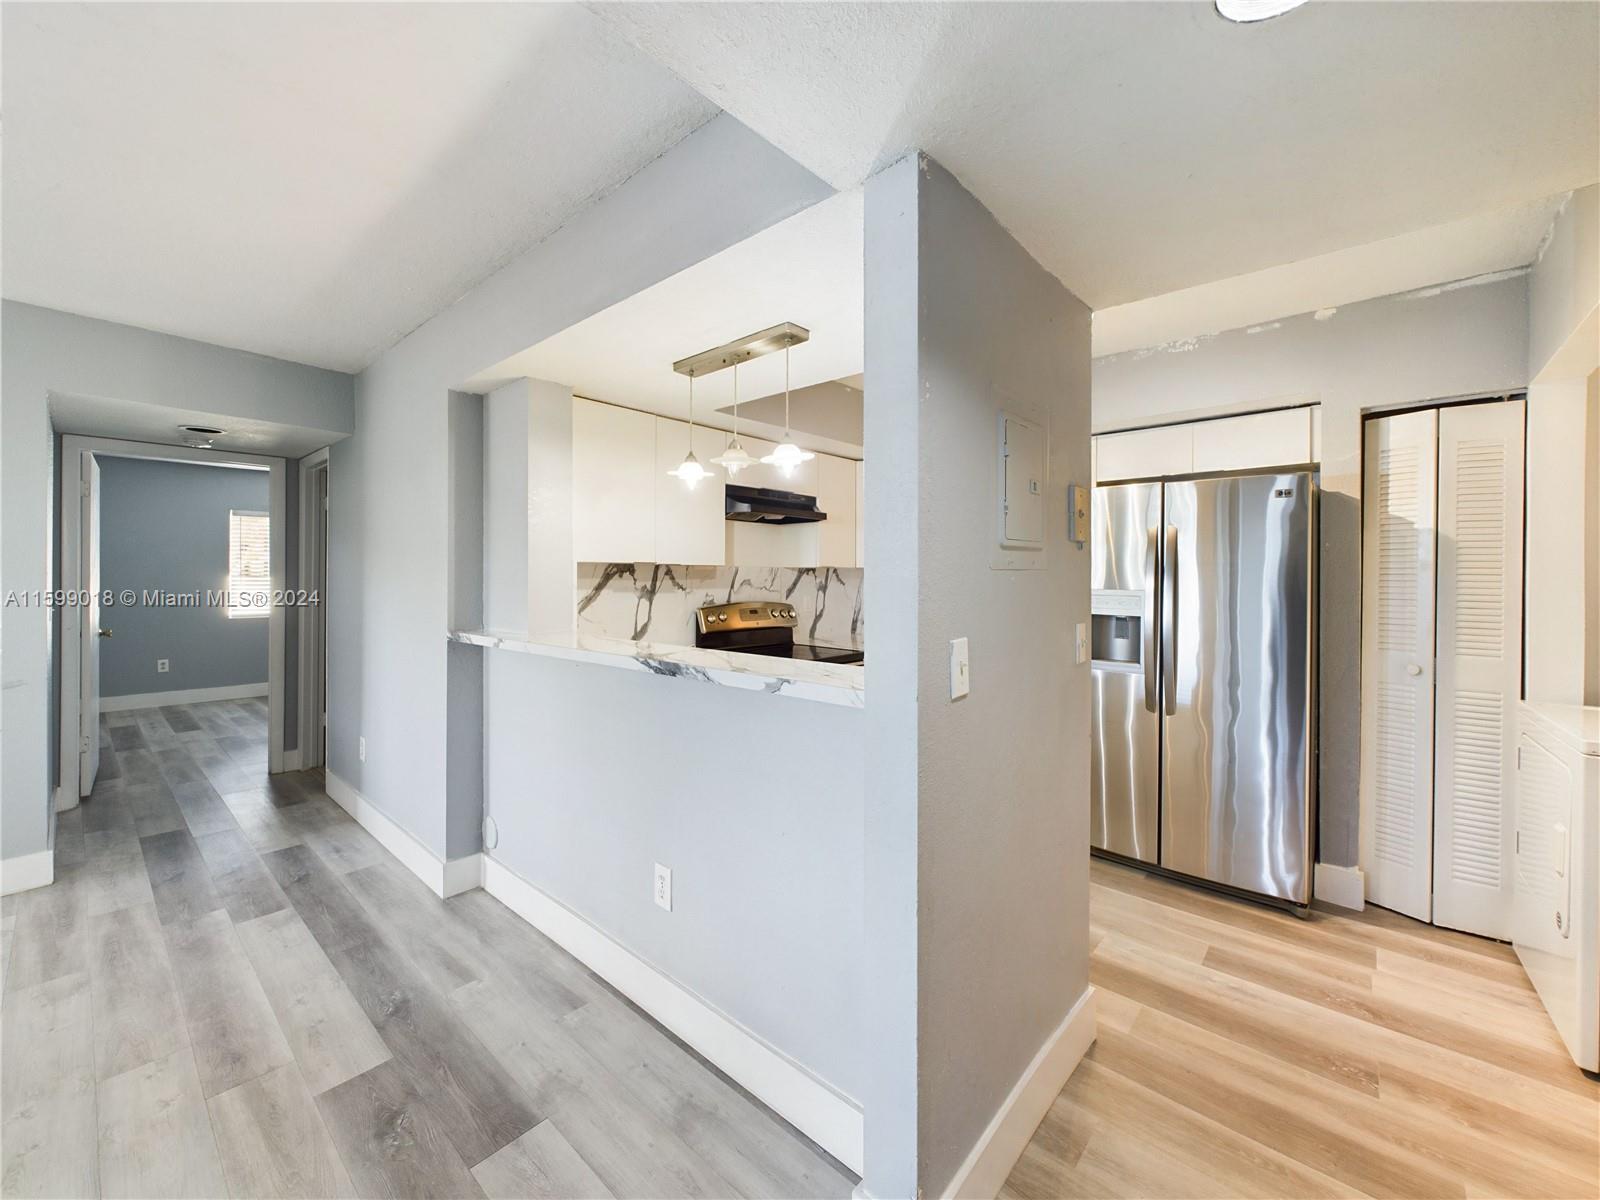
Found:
0,3 -> 715,370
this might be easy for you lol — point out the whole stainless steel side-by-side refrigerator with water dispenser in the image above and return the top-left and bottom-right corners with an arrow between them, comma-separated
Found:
1090,472 -> 1317,907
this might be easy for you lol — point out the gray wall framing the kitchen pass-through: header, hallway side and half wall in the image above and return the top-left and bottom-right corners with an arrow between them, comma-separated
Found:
328,117 -> 864,1107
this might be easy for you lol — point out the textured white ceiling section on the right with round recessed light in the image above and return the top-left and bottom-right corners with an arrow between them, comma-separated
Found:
592,0 -> 1600,309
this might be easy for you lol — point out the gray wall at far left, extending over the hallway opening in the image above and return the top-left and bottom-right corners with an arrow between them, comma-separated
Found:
0,301 -> 354,858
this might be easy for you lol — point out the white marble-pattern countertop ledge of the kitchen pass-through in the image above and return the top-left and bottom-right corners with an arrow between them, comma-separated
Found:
450,629 -> 866,709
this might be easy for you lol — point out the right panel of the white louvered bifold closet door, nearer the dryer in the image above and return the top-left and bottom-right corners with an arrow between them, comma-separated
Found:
1434,400 -> 1523,938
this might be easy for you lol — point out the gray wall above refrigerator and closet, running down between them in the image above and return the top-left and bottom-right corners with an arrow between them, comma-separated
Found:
1094,275 -> 1528,866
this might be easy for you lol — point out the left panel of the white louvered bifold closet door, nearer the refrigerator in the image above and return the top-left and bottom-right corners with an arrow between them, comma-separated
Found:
1362,410 -> 1438,920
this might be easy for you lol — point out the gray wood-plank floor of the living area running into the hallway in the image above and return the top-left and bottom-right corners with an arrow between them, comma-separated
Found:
0,701 -> 854,1197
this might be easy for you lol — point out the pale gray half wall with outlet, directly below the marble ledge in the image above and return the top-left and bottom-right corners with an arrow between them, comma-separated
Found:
483,651 -> 870,1096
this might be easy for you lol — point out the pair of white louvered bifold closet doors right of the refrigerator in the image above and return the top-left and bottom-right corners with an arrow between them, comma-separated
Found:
1362,397 -> 1526,939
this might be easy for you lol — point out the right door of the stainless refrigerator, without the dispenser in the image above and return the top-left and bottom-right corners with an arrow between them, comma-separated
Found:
1162,474 -> 1315,904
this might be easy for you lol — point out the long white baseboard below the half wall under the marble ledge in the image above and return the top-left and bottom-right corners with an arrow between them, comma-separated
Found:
483,854 -> 864,1174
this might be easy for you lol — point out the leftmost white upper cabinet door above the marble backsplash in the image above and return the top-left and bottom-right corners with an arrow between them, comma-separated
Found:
573,397 -> 656,563
